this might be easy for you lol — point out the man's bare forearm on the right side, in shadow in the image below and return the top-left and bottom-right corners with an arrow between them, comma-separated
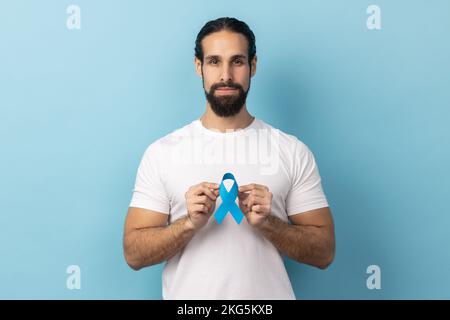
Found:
256,216 -> 334,269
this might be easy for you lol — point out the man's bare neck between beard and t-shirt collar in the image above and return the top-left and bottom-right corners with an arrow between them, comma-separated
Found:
200,104 -> 255,132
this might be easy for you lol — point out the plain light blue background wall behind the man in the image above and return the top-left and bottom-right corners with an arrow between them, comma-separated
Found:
0,0 -> 450,299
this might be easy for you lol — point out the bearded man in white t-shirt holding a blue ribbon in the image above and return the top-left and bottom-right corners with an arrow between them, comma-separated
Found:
124,18 -> 335,299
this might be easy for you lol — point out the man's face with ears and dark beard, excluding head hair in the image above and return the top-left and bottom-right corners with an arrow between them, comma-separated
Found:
195,30 -> 256,117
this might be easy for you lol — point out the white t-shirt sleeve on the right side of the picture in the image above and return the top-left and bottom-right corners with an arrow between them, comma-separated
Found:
286,139 -> 328,216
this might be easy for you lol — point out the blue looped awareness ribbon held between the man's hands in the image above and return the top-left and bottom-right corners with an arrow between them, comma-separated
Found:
214,172 -> 244,224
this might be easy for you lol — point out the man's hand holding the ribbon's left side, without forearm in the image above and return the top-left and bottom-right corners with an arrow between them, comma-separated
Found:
185,182 -> 219,230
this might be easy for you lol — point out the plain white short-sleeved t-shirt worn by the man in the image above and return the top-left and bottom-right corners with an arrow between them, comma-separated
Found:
130,118 -> 328,299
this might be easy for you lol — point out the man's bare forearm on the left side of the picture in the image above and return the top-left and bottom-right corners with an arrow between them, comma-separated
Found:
124,216 -> 195,270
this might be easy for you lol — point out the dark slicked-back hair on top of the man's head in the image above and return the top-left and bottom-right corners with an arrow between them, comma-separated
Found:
195,17 -> 256,63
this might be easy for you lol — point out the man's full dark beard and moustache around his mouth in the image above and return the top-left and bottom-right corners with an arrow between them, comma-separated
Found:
203,80 -> 250,117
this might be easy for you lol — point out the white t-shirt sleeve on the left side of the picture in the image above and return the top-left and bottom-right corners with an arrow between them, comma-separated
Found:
130,142 -> 170,214
